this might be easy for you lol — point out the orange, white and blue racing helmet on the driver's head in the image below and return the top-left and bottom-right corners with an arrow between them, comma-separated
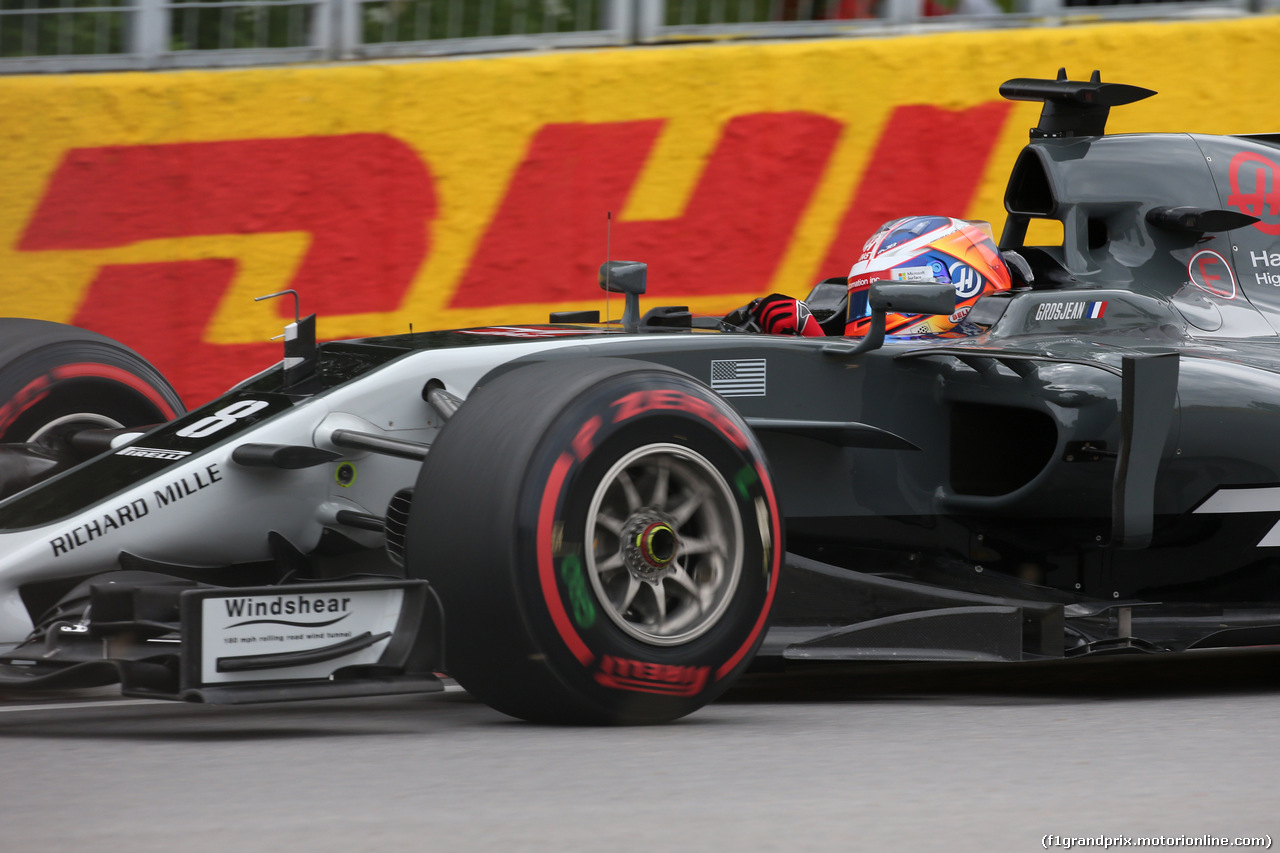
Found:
845,216 -> 1012,336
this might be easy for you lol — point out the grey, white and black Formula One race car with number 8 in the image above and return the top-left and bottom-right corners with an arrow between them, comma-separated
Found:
0,74 -> 1280,722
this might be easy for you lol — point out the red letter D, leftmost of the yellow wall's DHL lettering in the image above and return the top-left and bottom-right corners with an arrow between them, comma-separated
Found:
18,133 -> 436,405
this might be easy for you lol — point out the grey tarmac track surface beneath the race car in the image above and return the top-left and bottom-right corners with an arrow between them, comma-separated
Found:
0,651 -> 1280,852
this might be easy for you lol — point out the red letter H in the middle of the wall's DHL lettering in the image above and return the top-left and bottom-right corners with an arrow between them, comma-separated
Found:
451,113 -> 841,307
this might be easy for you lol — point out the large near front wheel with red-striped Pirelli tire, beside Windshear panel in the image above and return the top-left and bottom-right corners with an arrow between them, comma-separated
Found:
406,359 -> 782,724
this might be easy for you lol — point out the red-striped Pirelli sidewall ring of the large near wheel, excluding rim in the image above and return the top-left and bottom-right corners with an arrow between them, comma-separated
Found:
515,370 -> 783,721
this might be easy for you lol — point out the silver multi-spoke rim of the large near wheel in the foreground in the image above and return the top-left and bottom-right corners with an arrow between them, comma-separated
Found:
586,444 -> 742,646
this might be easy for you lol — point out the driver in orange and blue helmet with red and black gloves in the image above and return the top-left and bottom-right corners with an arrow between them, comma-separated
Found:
724,216 -> 1033,337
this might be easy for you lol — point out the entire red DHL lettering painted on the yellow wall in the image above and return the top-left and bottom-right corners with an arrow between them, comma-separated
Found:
15,101 -> 1008,405
